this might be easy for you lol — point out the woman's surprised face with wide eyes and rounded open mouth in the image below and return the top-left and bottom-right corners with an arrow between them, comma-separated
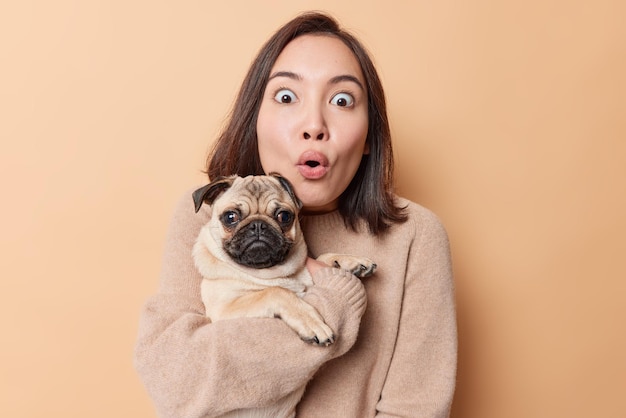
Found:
256,35 -> 369,212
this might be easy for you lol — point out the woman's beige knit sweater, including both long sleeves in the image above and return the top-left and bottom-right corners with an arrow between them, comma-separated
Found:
135,194 -> 457,418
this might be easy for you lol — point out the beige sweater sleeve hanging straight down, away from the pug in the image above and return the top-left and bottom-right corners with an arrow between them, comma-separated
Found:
377,207 -> 457,418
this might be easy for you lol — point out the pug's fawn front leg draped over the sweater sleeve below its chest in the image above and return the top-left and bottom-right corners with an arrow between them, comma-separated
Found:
221,287 -> 335,346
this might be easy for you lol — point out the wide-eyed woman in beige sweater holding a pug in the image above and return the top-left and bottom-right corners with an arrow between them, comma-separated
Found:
135,13 -> 457,418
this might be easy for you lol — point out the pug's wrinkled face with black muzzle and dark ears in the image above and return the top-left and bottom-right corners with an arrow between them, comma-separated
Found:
193,175 -> 305,269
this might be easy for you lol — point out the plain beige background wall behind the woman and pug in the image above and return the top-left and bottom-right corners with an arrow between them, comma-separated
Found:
0,0 -> 626,418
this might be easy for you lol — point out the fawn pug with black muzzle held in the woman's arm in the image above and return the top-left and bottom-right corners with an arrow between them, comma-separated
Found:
193,173 -> 376,418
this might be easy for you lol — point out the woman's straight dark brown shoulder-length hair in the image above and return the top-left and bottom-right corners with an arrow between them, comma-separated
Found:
207,12 -> 407,235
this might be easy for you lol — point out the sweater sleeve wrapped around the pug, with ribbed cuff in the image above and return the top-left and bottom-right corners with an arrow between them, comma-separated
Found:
134,196 -> 366,418
